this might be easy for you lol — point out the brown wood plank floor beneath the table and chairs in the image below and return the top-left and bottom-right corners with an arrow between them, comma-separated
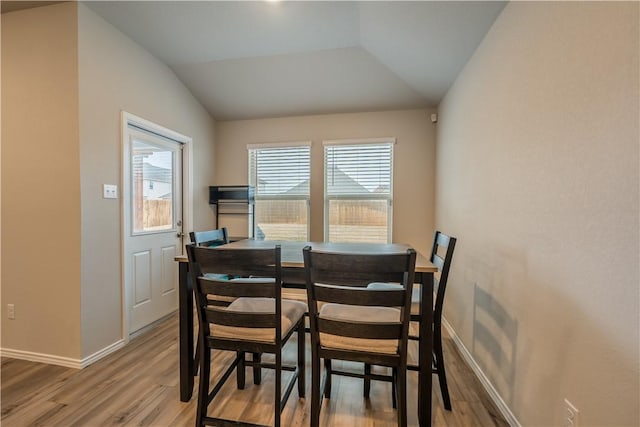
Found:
0,314 -> 508,427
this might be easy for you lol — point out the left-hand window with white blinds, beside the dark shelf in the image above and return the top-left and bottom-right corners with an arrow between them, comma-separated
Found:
248,142 -> 311,242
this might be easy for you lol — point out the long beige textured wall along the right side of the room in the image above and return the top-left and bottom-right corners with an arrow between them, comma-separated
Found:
436,2 -> 640,426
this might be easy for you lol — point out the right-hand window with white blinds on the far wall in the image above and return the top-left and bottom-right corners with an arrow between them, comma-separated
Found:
324,138 -> 395,243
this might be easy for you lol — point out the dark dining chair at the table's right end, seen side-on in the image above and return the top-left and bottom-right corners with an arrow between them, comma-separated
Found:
367,231 -> 457,411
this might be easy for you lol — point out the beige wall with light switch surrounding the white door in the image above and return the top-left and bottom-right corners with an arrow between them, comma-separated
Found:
78,4 -> 214,357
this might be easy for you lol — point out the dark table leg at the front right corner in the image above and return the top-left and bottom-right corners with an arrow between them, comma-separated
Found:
418,273 -> 433,427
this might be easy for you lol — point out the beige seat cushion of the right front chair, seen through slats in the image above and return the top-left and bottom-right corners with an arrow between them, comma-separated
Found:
319,303 -> 400,354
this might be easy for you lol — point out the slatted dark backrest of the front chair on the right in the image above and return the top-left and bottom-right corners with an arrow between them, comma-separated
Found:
303,246 -> 416,357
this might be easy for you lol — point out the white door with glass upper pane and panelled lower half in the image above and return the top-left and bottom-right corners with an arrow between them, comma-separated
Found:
123,124 -> 184,333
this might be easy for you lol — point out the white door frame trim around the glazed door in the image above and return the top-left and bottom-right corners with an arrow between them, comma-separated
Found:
120,110 -> 193,343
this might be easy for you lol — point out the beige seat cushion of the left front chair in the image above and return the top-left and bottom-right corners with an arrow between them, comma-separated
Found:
210,297 -> 307,343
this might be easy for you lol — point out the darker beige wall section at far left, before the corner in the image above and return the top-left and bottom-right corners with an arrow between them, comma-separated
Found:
1,3 -> 81,359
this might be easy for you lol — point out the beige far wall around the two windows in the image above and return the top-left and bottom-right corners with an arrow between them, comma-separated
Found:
215,110 -> 435,252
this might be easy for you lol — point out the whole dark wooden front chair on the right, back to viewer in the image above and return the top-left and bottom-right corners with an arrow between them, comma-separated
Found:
303,246 -> 416,427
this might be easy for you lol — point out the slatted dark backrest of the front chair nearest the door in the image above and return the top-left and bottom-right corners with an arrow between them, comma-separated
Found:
187,243 -> 282,345
